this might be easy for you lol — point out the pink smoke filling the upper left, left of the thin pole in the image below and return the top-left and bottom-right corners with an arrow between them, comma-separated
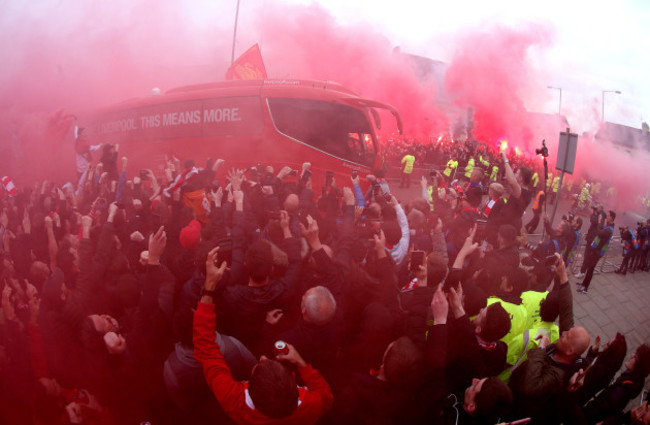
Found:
0,0 -> 229,182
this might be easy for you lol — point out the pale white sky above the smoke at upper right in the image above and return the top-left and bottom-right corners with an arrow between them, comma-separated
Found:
274,0 -> 650,128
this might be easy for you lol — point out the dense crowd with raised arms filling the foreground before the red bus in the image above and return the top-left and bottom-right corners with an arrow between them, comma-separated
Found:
0,140 -> 650,425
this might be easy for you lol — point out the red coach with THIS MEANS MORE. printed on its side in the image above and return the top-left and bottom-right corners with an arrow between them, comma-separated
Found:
81,79 -> 402,185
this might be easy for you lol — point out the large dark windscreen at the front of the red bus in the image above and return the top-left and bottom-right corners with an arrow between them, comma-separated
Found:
267,98 -> 377,167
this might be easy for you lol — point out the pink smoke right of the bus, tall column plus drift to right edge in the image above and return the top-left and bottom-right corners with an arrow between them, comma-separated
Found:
438,25 -> 648,213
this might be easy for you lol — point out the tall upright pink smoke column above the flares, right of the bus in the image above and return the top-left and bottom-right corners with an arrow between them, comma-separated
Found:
446,26 -> 550,151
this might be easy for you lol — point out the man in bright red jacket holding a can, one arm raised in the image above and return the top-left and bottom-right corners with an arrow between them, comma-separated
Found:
194,248 -> 334,424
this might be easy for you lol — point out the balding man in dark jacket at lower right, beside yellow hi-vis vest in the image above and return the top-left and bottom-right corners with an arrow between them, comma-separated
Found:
510,326 -> 591,423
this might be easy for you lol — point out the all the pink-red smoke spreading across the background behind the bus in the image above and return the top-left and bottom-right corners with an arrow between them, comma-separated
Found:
0,0 -> 645,215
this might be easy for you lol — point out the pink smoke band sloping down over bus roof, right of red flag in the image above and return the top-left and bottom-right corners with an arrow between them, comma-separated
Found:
257,4 -> 448,140
